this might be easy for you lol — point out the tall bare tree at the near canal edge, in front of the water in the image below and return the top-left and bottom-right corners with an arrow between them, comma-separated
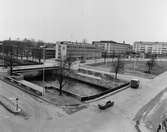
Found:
56,58 -> 72,95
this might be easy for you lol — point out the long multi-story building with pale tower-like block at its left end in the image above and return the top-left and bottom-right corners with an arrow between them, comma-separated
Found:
55,41 -> 102,59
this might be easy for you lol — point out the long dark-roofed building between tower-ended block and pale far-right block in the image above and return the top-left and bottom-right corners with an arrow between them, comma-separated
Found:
92,41 -> 132,56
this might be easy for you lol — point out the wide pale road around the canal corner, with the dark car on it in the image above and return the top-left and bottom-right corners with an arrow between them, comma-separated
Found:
0,66 -> 167,132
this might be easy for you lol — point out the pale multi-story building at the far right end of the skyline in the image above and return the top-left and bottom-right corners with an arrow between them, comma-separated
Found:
133,41 -> 167,55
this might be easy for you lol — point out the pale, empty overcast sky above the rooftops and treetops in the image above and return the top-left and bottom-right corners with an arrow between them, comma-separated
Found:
0,0 -> 167,43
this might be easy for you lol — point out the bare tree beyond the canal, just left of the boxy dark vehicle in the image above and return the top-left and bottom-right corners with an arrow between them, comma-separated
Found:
112,56 -> 124,79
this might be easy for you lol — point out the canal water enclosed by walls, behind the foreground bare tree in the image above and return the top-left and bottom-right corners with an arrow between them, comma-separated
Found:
24,72 -> 105,96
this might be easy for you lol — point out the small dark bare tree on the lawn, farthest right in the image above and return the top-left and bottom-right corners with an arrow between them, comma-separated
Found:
146,55 -> 156,73
